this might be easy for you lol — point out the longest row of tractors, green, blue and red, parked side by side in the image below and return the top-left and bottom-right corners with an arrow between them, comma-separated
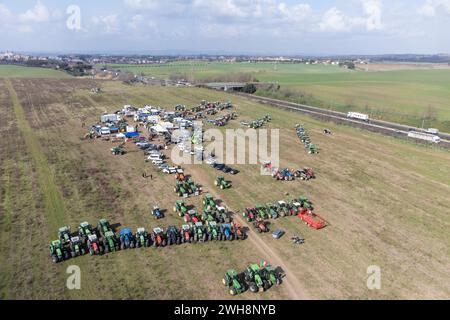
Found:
50,219 -> 246,263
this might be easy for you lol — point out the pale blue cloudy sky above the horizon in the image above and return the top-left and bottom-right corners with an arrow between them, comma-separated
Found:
0,0 -> 450,54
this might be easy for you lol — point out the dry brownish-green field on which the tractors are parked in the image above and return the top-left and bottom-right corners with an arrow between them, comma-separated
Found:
0,78 -> 450,300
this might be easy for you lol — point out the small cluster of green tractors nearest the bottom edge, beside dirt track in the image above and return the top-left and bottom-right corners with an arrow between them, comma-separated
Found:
222,261 -> 283,296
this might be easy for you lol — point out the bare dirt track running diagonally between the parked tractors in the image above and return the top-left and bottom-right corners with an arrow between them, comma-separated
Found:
189,166 -> 309,300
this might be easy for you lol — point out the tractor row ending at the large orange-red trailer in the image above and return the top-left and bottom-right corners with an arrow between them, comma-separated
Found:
242,196 -> 328,232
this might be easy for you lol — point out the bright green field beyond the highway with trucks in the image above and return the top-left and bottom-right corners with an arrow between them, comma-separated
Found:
109,62 -> 450,132
